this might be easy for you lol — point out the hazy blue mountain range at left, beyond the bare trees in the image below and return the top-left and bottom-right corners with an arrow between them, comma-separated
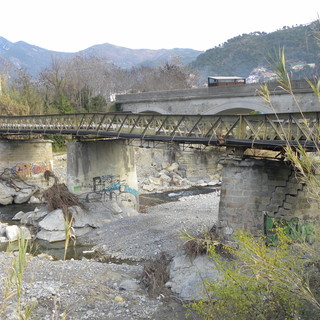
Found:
0,37 -> 203,76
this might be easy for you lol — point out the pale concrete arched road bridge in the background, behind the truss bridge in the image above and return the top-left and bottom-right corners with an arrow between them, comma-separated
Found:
116,80 -> 319,115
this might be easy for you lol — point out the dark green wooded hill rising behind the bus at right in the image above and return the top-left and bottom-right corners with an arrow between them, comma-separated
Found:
191,21 -> 320,77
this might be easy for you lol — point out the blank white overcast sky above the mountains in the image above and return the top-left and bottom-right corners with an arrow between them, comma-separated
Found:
0,0 -> 320,52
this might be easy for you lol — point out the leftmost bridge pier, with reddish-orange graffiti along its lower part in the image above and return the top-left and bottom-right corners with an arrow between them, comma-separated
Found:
0,140 -> 53,186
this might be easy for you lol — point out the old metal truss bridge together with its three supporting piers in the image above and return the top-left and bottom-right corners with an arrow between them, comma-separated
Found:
0,112 -> 320,239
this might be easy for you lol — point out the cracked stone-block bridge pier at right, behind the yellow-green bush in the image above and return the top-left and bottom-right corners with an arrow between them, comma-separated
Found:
217,158 -> 320,240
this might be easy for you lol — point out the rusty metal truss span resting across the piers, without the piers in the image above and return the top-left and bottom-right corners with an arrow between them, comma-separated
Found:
0,112 -> 320,151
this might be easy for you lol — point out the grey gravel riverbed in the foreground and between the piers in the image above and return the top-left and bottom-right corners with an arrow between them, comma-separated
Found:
0,192 -> 219,320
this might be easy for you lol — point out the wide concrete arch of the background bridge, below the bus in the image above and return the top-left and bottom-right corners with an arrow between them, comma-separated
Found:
204,98 -> 273,114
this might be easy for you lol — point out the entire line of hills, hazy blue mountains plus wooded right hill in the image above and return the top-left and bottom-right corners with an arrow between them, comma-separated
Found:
0,21 -> 320,79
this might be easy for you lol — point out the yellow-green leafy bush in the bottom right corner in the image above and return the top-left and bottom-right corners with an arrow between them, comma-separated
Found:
191,227 -> 320,320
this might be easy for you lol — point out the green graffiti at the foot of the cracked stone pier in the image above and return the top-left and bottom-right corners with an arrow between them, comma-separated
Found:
264,215 -> 314,243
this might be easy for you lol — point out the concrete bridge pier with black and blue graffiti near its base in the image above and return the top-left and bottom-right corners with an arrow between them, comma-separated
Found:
67,140 -> 139,210
